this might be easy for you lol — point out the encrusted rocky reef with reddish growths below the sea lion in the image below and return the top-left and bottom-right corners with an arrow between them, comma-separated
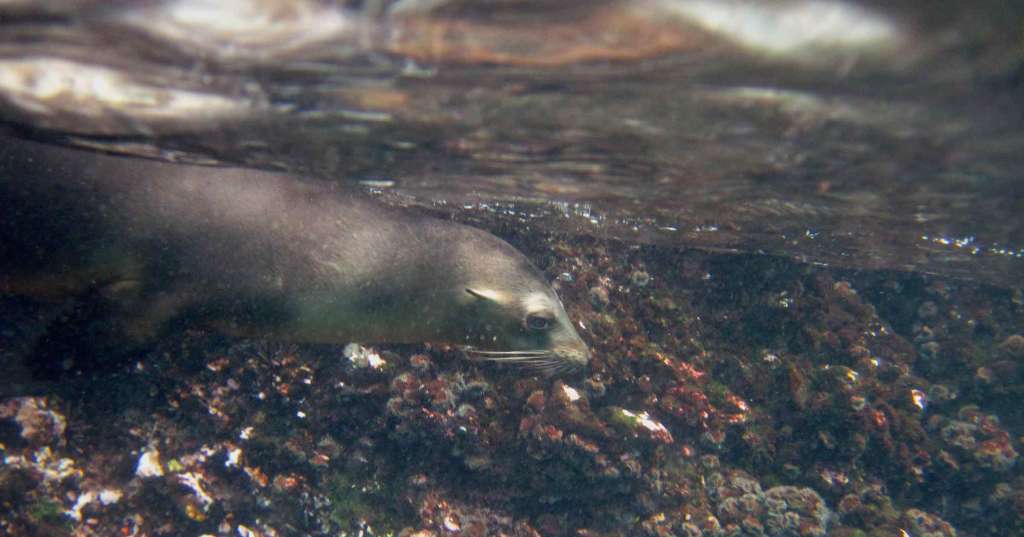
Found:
0,235 -> 1024,537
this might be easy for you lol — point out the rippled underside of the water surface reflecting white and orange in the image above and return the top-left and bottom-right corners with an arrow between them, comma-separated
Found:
0,0 -> 1024,285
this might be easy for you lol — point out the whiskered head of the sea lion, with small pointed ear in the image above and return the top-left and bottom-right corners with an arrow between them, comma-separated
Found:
456,231 -> 590,374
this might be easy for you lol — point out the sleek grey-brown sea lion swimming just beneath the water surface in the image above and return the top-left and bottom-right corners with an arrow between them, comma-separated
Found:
0,139 -> 589,373
